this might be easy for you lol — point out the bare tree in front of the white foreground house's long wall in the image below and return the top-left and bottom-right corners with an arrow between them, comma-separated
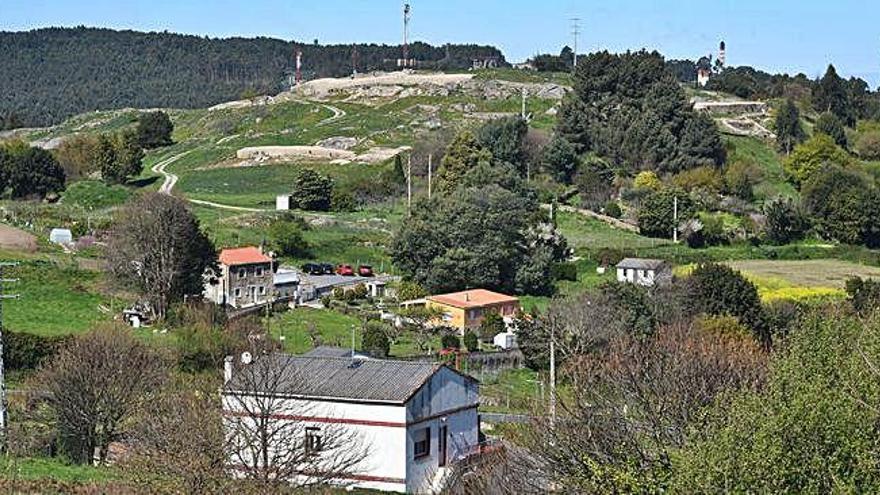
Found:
223,354 -> 369,487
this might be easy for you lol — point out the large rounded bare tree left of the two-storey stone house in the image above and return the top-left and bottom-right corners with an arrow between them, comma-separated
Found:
107,193 -> 216,318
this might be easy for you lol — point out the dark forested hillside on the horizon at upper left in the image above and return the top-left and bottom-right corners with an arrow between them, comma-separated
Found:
0,27 -> 504,129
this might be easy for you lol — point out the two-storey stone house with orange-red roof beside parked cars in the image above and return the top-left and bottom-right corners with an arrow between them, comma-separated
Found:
205,246 -> 274,308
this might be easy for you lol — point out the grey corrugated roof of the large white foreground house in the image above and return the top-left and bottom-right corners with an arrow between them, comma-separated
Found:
224,354 -> 441,404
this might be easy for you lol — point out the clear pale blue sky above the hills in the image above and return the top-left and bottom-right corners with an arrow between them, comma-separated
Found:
0,0 -> 880,87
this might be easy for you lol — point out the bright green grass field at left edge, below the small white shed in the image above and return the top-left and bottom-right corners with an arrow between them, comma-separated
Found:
3,260 -> 113,335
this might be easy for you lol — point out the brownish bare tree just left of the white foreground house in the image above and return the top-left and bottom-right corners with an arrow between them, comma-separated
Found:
123,375 -> 228,493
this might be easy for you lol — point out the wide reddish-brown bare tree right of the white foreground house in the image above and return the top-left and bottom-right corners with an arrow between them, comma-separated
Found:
521,324 -> 767,493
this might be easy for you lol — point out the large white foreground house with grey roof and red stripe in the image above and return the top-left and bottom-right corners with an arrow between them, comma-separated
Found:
221,354 -> 480,493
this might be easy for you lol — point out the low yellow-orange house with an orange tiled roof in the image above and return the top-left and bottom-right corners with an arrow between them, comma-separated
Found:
425,289 -> 520,333
